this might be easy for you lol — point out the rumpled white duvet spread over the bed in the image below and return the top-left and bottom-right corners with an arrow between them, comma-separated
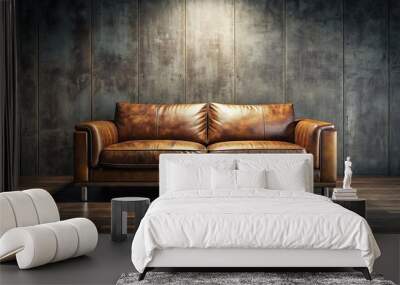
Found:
132,189 -> 380,272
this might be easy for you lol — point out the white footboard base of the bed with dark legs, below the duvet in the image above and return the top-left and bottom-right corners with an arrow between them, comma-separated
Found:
139,248 -> 371,280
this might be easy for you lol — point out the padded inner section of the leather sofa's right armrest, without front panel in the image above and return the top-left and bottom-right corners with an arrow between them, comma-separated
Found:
294,119 -> 335,169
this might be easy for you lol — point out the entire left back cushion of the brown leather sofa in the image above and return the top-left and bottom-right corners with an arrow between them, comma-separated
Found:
115,102 -> 207,144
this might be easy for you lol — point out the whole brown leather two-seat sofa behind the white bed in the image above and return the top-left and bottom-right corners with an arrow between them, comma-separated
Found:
74,103 -> 337,200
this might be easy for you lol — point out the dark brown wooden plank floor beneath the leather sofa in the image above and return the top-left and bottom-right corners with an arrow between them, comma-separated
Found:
21,177 -> 400,234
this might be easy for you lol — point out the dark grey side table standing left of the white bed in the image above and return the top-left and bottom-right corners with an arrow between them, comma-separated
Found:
111,197 -> 150,241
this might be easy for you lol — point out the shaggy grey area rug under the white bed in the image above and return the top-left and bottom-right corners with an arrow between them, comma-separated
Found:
117,272 -> 395,285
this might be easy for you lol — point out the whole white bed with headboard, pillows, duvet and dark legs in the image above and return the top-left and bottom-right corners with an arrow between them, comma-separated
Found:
132,154 -> 380,278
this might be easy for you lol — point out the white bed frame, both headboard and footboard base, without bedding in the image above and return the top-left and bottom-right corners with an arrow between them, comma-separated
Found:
139,154 -> 371,280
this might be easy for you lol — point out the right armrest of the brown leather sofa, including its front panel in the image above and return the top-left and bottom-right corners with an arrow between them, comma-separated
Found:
294,119 -> 337,182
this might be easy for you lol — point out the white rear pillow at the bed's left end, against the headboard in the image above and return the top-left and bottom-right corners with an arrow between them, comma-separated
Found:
167,163 -> 211,191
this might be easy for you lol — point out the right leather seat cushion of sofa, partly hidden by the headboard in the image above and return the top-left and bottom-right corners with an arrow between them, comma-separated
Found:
207,140 -> 306,153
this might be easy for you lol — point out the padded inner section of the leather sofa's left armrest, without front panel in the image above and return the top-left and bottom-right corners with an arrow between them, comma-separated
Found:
75,121 -> 118,167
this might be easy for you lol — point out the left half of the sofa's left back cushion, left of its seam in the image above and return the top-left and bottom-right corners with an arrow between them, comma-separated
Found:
115,102 -> 157,141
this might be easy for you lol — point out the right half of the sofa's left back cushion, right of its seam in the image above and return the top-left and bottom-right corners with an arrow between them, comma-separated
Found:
157,104 -> 207,144
